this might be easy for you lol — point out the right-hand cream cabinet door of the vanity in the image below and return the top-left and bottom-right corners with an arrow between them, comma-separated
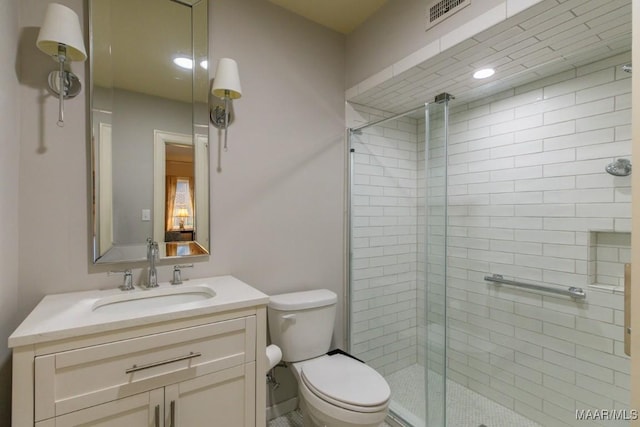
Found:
164,362 -> 256,427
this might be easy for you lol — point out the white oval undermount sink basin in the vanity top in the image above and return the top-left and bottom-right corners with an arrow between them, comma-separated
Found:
91,286 -> 216,313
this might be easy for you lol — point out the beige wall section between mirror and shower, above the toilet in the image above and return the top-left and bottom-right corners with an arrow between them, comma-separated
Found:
209,0 -> 344,342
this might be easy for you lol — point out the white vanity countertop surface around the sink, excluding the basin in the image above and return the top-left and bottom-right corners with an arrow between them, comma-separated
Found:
9,276 -> 269,348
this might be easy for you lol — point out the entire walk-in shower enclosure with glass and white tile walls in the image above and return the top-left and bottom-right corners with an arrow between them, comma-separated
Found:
348,52 -> 637,427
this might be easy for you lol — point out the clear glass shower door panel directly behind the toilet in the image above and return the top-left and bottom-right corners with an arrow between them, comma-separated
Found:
348,98 -> 447,427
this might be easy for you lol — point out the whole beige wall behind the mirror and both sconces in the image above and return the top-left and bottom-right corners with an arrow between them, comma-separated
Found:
10,0 -> 345,414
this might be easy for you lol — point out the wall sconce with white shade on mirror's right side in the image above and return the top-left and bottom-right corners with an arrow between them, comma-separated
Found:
210,58 -> 242,151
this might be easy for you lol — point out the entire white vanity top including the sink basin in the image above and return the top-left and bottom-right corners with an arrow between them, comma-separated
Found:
9,275 -> 269,348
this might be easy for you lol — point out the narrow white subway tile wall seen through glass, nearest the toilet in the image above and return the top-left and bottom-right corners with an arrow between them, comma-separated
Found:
351,108 -> 424,374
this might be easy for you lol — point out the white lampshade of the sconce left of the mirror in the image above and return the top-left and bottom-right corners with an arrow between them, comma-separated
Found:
36,3 -> 87,61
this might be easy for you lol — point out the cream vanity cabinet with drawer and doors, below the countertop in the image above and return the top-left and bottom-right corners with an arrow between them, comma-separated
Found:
10,278 -> 268,427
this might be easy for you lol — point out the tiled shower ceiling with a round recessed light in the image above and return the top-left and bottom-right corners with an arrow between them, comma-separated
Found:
349,0 -> 631,113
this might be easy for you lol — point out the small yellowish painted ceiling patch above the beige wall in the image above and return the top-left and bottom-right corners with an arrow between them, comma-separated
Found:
269,0 -> 387,34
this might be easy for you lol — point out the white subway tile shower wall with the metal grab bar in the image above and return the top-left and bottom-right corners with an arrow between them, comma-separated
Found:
447,54 -> 631,426
